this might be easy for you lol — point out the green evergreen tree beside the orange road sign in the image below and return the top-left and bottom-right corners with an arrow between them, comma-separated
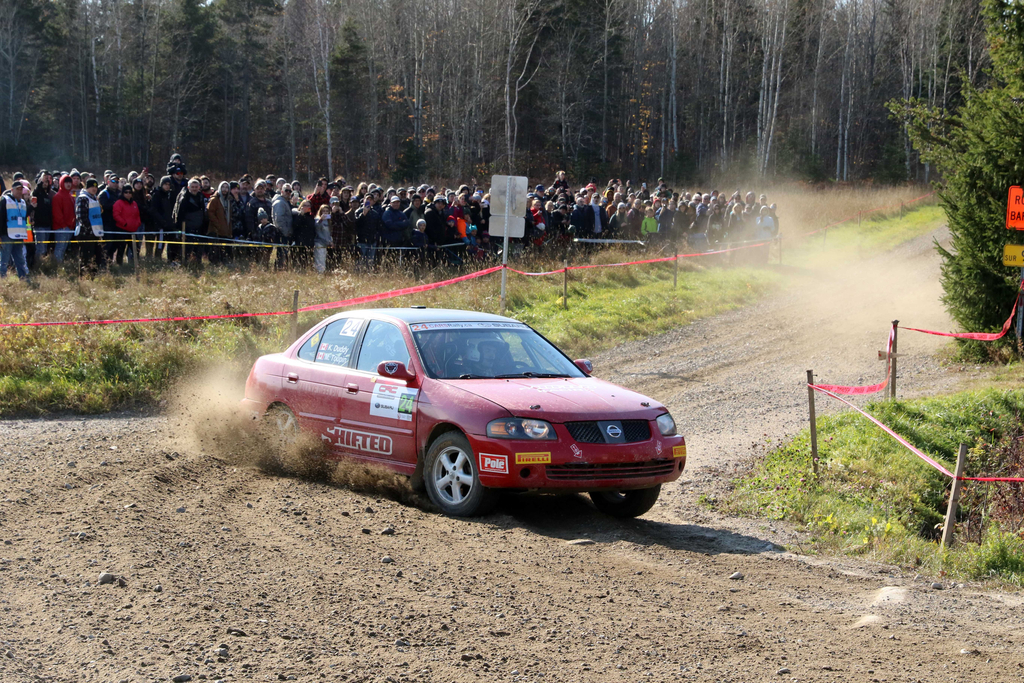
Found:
891,0 -> 1024,357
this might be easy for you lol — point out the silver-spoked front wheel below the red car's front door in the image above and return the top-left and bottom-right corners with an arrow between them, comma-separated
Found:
423,431 -> 498,517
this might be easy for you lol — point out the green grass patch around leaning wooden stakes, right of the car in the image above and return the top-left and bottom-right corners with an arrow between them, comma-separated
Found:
725,389 -> 1024,585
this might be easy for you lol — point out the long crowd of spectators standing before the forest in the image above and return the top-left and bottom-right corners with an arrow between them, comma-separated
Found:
0,155 -> 778,278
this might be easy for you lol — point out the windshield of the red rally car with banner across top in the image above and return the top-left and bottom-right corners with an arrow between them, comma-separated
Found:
410,323 -> 586,380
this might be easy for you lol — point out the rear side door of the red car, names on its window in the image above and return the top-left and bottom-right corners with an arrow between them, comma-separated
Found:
285,317 -> 365,443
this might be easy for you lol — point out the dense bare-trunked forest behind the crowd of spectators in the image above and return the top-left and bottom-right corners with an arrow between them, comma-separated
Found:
0,0 -> 989,182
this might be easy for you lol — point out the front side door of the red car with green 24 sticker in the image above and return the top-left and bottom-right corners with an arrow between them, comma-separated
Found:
341,321 -> 419,474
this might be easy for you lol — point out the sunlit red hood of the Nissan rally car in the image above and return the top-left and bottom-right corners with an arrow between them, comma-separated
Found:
445,377 -> 665,422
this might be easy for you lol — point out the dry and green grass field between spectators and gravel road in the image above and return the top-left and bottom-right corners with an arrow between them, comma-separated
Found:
0,184 -> 942,415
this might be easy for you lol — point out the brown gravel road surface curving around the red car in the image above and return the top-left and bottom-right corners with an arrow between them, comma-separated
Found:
0,228 -> 1024,683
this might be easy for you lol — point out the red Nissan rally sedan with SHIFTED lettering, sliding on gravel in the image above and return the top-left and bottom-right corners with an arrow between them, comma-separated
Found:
243,306 -> 686,517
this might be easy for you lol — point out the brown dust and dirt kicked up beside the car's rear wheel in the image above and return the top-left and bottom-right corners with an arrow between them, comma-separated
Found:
168,368 -> 432,510
